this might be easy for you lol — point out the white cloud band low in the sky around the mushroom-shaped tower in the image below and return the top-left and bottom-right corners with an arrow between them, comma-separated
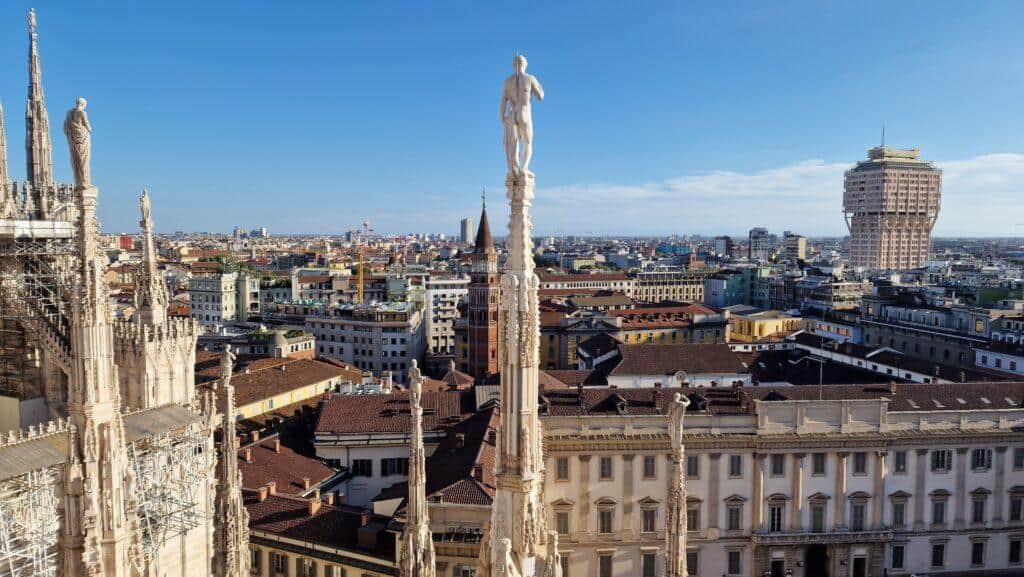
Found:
535,153 -> 1024,236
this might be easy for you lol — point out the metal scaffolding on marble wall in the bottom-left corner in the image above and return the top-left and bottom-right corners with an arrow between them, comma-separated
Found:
0,467 -> 60,577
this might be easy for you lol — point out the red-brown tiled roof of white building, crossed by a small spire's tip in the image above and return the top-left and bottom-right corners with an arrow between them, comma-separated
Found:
315,390 -> 474,435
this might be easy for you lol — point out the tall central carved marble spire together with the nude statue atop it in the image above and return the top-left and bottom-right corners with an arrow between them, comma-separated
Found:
477,55 -> 561,577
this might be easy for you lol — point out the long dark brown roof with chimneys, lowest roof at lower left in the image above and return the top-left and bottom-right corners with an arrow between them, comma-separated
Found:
245,492 -> 394,562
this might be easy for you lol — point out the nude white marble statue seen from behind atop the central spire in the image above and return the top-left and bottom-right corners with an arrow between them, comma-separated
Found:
499,54 -> 544,177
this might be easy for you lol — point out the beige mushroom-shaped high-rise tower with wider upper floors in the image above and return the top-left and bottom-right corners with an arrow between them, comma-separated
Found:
843,147 -> 942,270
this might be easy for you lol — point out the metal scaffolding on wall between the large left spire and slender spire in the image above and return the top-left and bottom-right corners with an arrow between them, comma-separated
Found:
129,424 -> 210,559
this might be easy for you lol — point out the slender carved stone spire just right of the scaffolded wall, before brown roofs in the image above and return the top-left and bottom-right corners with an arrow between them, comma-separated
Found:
211,344 -> 250,577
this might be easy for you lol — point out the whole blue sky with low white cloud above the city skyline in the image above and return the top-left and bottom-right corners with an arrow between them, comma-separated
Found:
0,0 -> 1024,235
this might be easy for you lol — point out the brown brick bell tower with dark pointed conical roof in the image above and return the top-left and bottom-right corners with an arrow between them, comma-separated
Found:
467,204 -> 500,379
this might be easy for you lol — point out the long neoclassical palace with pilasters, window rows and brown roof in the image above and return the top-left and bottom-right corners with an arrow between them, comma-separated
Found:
542,383 -> 1024,577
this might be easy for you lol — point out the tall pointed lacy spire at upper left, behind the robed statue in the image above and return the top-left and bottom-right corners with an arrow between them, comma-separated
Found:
25,9 -> 53,188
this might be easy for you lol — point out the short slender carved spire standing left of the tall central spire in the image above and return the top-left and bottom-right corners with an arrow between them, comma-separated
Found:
398,360 -> 436,577
